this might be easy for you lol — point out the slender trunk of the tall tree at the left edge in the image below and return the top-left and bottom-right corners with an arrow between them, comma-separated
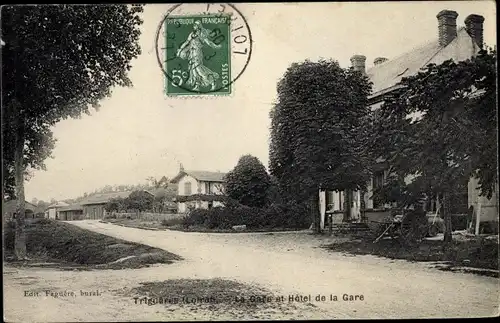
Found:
11,104 -> 27,260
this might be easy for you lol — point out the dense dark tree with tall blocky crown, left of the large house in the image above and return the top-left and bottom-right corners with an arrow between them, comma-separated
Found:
270,60 -> 371,231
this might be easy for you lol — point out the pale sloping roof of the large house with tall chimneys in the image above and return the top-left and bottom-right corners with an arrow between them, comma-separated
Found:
366,27 -> 479,97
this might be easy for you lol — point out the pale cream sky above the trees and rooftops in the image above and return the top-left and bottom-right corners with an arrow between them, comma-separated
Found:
25,1 -> 496,201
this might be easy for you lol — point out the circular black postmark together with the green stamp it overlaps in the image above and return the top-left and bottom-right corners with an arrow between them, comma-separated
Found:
155,3 -> 253,96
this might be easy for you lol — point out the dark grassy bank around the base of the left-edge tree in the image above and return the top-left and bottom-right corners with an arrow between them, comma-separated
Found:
4,219 -> 181,269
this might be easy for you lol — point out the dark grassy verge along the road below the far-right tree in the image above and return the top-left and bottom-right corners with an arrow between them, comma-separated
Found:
324,237 -> 498,276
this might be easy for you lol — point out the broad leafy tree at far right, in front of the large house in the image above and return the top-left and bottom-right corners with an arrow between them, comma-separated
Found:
372,50 -> 498,243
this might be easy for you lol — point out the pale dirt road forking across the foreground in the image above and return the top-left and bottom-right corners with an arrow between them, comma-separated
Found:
4,221 -> 499,322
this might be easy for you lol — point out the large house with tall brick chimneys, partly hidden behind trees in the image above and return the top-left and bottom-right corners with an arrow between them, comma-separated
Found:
320,10 -> 498,230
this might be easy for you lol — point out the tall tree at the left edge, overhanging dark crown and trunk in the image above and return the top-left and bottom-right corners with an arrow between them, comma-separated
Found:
1,5 -> 142,258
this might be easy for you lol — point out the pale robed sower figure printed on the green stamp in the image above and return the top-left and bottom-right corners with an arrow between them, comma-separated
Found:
177,20 -> 221,91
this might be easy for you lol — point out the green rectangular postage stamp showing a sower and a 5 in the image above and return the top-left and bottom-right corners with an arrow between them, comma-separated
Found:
164,14 -> 232,95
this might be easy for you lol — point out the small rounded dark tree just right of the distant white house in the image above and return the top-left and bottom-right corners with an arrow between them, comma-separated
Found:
225,155 -> 271,207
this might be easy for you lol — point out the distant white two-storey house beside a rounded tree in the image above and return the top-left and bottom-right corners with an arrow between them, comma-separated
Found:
170,167 -> 226,213
